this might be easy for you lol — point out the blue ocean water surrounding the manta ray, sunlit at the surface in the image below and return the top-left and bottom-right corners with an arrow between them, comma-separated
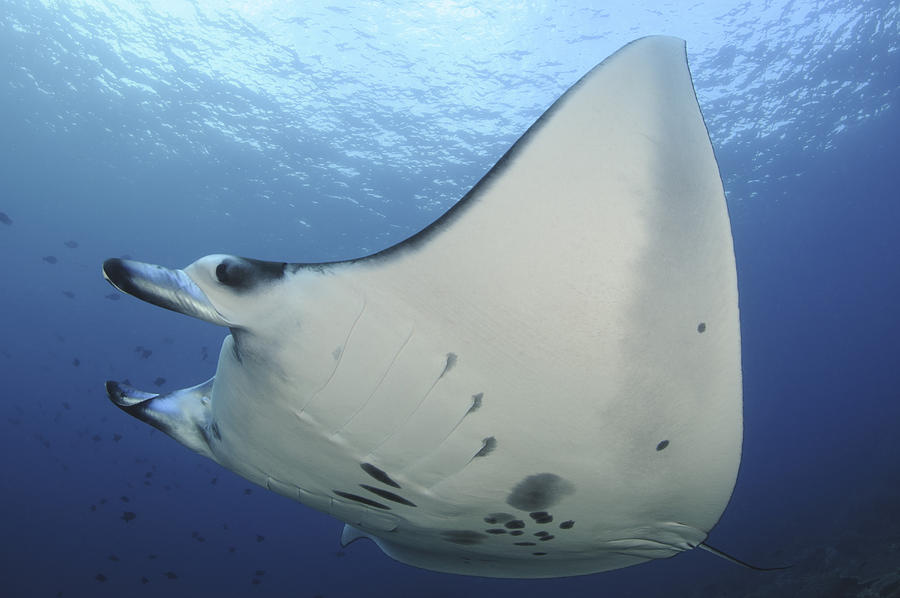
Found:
0,0 -> 900,598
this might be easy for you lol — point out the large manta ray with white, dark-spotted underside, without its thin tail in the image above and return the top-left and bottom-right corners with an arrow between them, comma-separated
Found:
103,37 -> 742,577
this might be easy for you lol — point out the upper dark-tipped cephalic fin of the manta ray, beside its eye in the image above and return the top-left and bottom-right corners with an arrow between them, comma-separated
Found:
103,258 -> 229,326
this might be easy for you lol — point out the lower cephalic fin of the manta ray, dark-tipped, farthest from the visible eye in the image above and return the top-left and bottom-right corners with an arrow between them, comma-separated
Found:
106,377 -> 219,459
